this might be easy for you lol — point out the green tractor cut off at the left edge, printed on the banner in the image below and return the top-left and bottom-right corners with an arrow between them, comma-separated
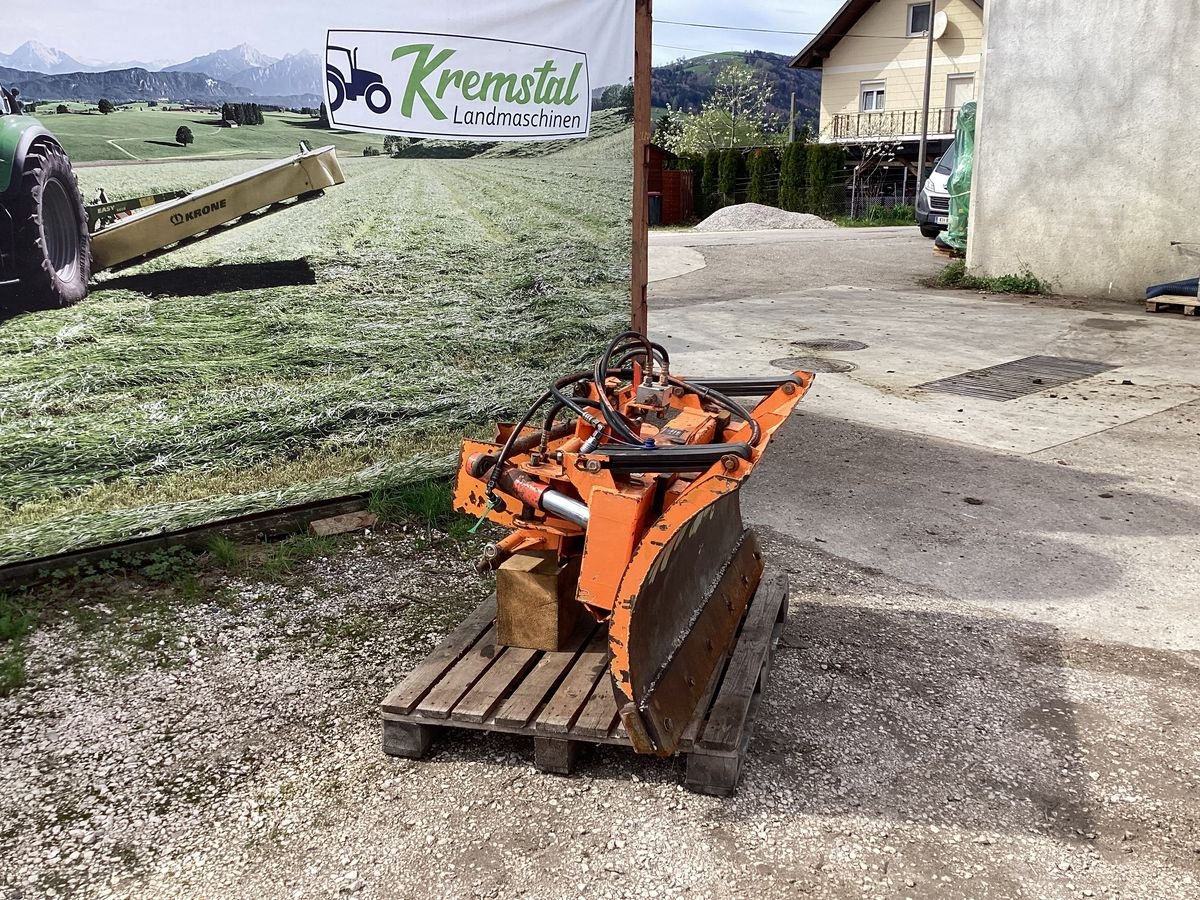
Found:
0,86 -> 91,308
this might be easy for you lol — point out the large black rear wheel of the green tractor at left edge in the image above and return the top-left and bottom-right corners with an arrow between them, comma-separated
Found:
13,144 -> 91,308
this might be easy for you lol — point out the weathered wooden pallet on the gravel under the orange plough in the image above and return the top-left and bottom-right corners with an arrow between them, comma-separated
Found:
383,569 -> 787,796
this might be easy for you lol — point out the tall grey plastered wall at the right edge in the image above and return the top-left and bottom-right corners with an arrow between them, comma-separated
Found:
967,0 -> 1200,298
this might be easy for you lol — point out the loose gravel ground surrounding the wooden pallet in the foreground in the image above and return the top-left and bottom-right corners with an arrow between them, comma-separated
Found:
0,530 -> 1200,898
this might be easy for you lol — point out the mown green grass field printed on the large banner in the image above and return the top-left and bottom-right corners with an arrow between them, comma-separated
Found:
0,116 -> 631,563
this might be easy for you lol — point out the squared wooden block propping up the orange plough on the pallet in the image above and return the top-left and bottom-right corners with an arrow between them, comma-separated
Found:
496,553 -> 583,650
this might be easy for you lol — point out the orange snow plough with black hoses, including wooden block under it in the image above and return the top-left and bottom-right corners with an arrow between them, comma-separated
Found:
455,331 -> 812,756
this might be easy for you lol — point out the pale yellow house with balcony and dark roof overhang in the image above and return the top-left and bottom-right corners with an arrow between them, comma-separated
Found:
791,0 -> 983,144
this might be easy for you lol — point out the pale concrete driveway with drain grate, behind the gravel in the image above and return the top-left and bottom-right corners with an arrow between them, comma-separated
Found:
650,228 -> 1200,650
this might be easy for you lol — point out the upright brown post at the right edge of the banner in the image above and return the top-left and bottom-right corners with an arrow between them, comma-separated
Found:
629,0 -> 654,335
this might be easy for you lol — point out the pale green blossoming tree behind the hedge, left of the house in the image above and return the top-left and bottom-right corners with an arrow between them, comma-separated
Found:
667,62 -> 781,156
